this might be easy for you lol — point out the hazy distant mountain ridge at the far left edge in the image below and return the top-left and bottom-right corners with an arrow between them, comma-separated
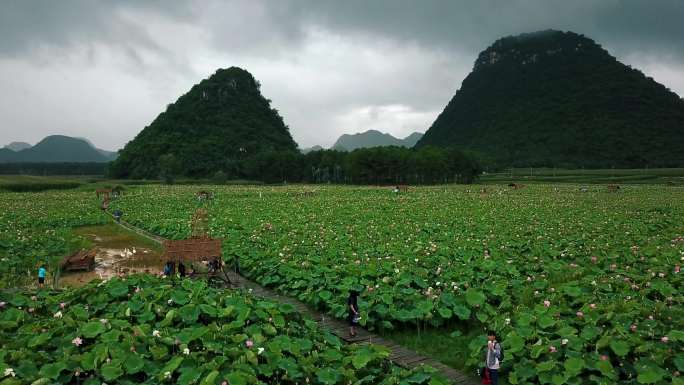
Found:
0,135 -> 117,163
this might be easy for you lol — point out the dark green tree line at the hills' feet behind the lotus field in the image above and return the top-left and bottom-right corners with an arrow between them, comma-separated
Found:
151,146 -> 481,184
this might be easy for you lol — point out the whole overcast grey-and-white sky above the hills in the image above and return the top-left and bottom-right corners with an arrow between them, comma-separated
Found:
0,0 -> 684,150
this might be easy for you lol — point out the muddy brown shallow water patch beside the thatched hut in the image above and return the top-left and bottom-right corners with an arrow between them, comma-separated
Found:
60,225 -> 164,287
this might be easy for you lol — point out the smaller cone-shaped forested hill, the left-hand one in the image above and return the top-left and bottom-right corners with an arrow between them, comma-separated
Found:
110,67 -> 297,178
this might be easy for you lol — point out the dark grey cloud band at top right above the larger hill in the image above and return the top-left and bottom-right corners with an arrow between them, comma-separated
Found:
272,0 -> 684,56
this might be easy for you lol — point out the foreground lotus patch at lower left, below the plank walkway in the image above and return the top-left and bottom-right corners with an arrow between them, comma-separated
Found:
0,276 -> 442,385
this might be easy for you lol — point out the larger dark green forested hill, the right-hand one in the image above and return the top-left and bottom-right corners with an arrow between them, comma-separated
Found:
417,30 -> 684,167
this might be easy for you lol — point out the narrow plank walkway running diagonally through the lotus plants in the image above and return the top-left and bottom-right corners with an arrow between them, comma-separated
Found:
111,216 -> 479,385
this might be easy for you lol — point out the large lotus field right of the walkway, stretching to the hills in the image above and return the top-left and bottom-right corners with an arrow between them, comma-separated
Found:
109,186 -> 684,384
